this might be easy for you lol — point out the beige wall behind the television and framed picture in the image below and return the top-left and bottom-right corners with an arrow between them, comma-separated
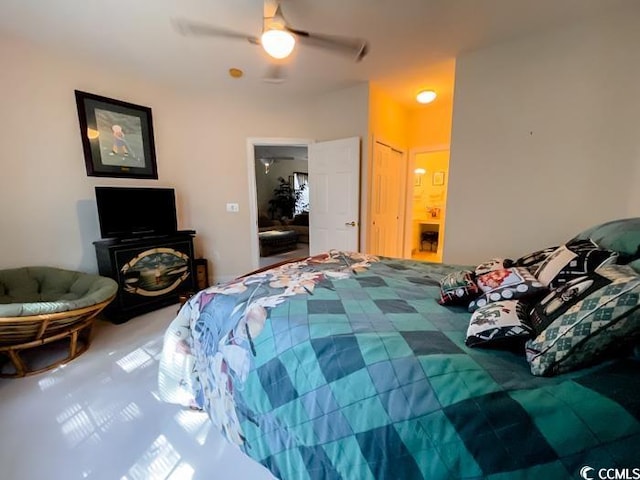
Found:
0,37 -> 367,280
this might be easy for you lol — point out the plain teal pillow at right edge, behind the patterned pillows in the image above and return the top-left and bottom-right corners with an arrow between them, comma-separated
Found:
573,217 -> 640,263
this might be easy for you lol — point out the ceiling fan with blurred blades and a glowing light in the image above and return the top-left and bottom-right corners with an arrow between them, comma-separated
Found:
173,0 -> 369,83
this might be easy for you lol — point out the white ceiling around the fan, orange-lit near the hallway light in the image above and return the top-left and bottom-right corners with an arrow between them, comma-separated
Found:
0,0 -> 637,105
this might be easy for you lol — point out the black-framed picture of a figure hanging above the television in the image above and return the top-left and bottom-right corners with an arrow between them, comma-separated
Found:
75,90 -> 158,179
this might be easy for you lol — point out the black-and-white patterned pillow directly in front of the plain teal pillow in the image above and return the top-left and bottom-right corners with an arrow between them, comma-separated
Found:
534,240 -> 618,288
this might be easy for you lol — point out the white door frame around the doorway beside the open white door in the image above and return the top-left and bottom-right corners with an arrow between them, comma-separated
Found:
247,137 -> 315,270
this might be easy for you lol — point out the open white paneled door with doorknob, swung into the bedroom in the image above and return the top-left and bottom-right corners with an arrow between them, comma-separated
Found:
309,137 -> 360,255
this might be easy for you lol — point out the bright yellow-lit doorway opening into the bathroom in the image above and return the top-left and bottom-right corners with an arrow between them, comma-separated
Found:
405,147 -> 449,263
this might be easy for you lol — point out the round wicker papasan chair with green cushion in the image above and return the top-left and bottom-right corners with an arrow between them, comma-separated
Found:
0,267 -> 118,377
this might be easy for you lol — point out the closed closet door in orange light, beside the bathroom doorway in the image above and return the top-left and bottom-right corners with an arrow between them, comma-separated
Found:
370,142 -> 405,257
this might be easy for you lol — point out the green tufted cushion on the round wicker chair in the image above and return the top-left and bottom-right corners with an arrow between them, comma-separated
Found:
0,267 -> 118,317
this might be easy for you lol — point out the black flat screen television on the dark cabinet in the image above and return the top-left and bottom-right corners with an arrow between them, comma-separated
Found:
95,187 -> 178,238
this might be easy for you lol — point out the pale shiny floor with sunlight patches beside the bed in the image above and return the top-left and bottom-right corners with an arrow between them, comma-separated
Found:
0,305 -> 273,480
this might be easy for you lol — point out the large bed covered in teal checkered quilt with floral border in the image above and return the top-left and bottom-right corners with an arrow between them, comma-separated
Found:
159,219 -> 640,480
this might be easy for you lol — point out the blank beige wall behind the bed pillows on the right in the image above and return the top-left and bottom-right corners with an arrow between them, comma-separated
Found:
444,4 -> 640,263
